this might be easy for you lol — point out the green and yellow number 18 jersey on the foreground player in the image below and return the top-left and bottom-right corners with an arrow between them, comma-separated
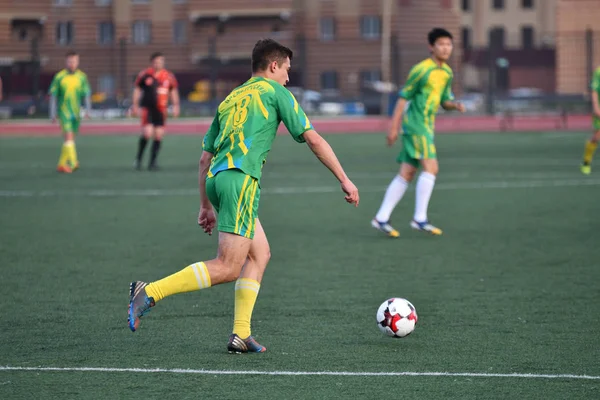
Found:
203,77 -> 313,180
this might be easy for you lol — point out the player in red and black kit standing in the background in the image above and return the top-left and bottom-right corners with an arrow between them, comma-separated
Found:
132,53 -> 179,170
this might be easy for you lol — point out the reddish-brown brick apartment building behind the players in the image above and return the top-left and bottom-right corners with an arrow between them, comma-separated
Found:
0,0 -> 461,96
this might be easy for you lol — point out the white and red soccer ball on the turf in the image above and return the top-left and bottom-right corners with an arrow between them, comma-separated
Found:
377,297 -> 418,337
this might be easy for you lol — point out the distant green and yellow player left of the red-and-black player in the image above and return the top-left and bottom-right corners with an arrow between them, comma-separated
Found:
49,52 -> 91,173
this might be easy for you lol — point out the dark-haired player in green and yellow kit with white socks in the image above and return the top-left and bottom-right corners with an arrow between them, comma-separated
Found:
371,28 -> 465,237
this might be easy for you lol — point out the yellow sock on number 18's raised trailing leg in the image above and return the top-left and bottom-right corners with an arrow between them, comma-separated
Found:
146,262 -> 210,302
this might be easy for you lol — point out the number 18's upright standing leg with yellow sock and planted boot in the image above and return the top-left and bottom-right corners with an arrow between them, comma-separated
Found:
227,218 -> 271,353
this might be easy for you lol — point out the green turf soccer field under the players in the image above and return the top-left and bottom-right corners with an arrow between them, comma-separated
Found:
0,132 -> 600,399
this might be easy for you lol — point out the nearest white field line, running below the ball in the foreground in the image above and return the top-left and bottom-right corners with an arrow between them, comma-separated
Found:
0,366 -> 600,380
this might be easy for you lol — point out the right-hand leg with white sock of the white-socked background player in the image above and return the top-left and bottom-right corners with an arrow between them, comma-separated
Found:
410,158 -> 442,235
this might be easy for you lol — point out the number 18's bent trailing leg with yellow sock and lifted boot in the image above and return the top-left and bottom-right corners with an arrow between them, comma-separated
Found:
128,232 -> 252,332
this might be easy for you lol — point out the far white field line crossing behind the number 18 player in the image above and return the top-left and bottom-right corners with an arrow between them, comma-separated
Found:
0,179 -> 600,198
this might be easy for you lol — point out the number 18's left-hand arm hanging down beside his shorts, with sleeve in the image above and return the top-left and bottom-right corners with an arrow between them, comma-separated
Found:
198,113 -> 220,235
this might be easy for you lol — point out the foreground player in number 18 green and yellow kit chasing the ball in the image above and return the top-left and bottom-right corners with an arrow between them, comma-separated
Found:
129,39 -> 359,353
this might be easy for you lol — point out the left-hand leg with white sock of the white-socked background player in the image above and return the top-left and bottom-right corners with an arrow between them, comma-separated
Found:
371,163 -> 417,238
